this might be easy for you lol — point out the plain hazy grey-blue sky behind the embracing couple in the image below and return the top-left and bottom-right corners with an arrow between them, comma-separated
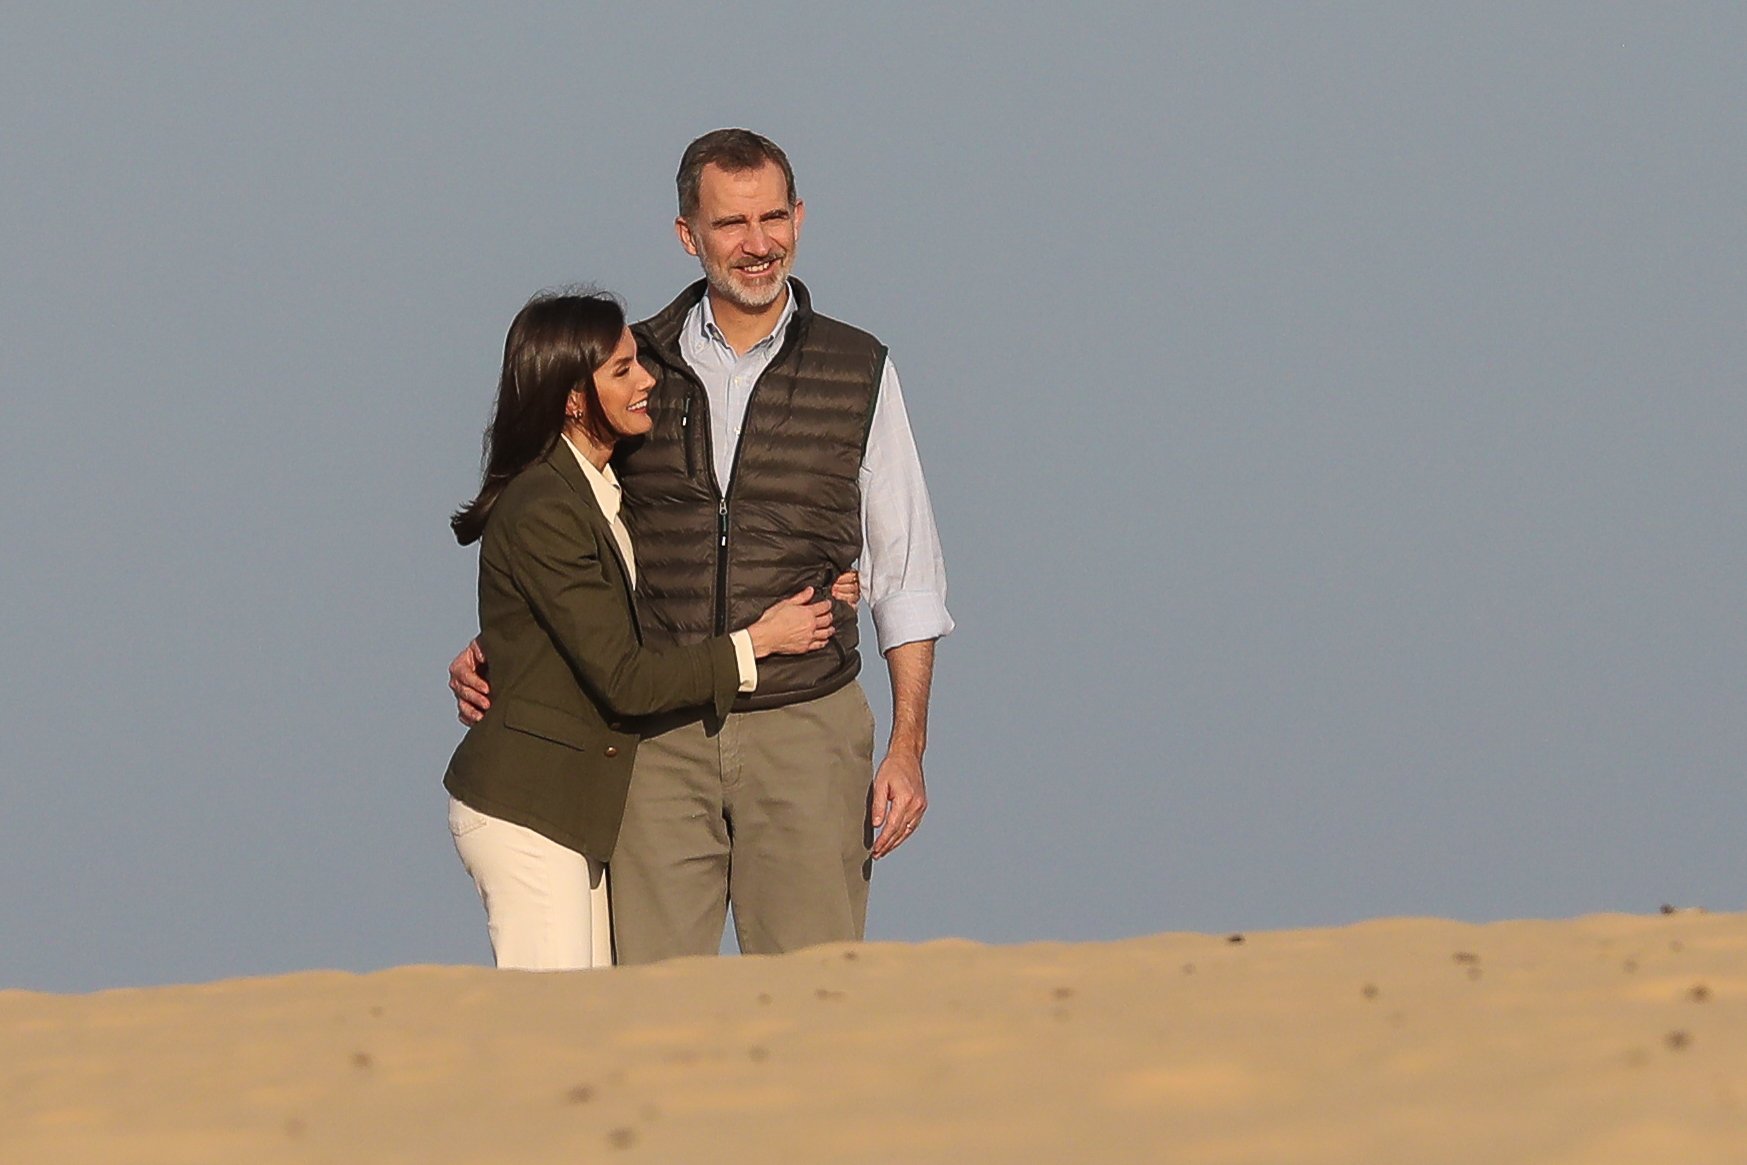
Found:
0,2 -> 1747,992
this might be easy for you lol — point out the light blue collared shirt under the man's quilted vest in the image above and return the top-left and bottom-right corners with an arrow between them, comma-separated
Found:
680,284 -> 952,653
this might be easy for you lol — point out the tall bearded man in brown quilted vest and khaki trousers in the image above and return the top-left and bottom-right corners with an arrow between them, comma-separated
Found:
449,129 -> 952,962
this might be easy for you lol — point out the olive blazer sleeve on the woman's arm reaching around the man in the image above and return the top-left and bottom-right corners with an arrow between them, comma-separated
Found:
505,496 -> 741,716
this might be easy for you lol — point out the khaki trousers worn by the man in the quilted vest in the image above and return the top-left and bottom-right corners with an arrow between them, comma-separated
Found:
613,683 -> 874,964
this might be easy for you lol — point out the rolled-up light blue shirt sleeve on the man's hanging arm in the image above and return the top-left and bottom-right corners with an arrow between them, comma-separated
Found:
860,360 -> 952,653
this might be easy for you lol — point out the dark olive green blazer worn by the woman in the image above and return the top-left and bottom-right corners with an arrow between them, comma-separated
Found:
444,440 -> 739,861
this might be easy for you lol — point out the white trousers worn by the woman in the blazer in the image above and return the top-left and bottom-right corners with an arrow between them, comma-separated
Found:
449,796 -> 613,971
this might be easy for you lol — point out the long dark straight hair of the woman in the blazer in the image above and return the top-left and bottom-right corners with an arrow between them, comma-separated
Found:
449,292 -> 625,547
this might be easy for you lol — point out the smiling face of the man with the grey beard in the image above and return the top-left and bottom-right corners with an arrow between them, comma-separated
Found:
674,162 -> 807,311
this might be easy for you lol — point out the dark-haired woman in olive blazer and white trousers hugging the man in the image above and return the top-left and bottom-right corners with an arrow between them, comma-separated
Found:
444,295 -> 832,969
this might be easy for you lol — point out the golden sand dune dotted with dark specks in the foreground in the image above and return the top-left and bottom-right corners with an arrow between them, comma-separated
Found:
0,912 -> 1747,1165
